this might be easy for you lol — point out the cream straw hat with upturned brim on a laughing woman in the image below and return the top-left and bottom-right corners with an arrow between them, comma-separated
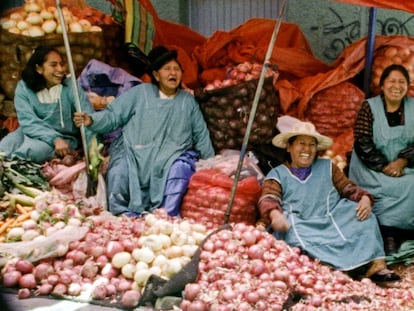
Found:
272,116 -> 333,151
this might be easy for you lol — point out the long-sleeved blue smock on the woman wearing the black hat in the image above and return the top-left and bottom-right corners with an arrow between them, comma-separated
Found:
89,83 -> 214,215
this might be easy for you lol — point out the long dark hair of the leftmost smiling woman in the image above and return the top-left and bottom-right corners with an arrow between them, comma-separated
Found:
22,46 -> 61,93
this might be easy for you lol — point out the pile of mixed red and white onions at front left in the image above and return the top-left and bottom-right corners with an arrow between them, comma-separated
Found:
2,210 -> 207,307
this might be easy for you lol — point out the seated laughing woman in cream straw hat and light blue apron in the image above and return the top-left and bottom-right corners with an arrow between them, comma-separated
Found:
258,116 -> 400,282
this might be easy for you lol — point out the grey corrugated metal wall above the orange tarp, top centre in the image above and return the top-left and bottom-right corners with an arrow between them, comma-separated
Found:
188,0 -> 283,36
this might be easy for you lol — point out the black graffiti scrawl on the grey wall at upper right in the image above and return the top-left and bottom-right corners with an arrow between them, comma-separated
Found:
311,8 -> 414,61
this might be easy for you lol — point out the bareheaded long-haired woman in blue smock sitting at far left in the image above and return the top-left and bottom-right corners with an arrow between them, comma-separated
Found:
0,47 -> 93,163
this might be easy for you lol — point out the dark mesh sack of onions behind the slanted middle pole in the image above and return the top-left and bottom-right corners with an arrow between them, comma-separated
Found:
196,69 -> 279,152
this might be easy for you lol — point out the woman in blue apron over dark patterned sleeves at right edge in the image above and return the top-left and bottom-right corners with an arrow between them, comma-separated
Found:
349,65 -> 414,254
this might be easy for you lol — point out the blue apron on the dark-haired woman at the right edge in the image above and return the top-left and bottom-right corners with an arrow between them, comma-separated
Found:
349,96 -> 414,230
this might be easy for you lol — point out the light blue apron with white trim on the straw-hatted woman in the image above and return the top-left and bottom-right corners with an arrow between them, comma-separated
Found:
266,159 -> 385,271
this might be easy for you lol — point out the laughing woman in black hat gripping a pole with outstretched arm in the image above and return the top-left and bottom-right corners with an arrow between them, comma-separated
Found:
75,46 -> 214,216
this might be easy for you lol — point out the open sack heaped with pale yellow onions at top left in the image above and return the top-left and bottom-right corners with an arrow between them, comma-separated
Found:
0,0 -> 110,99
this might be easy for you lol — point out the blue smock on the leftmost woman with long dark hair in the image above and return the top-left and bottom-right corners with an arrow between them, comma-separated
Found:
0,78 -> 93,163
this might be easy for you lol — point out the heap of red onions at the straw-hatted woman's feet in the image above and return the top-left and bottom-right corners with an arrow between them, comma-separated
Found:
181,224 -> 414,311
